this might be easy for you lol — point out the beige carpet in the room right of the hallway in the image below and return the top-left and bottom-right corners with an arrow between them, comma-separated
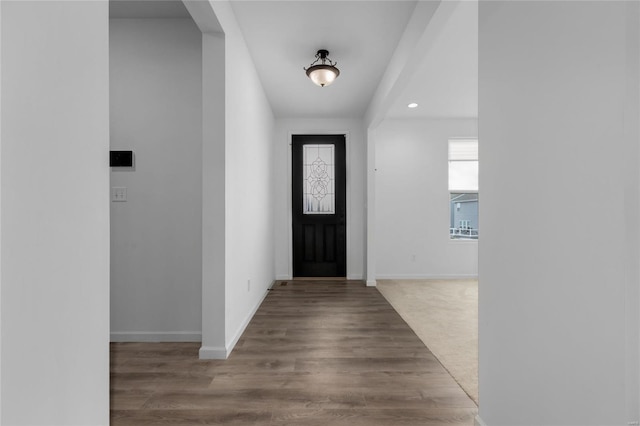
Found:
378,280 -> 478,404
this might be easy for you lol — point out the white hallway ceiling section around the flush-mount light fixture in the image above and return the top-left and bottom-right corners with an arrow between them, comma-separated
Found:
232,0 -> 416,117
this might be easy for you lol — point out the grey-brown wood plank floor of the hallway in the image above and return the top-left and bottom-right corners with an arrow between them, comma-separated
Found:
111,280 -> 477,426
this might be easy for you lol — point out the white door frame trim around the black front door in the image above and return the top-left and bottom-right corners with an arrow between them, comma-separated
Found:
285,129 -> 353,279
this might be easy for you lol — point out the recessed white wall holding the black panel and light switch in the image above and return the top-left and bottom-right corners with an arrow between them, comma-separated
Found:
110,19 -> 202,341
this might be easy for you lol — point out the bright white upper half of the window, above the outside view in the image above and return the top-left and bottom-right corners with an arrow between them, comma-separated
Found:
449,139 -> 478,191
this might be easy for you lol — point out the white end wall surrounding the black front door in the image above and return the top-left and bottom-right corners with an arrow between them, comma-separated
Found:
274,118 -> 366,280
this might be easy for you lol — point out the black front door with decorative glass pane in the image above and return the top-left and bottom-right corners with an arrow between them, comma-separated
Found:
291,135 -> 347,277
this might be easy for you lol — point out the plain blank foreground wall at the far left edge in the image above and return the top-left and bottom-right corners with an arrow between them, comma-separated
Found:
0,1 -> 109,426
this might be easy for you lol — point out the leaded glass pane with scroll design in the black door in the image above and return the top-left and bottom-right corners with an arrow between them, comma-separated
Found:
302,145 -> 336,214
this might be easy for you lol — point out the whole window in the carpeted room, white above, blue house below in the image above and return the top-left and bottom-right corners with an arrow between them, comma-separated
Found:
449,139 -> 478,240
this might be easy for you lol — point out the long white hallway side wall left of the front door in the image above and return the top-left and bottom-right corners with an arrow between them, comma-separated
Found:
225,27 -> 275,349
